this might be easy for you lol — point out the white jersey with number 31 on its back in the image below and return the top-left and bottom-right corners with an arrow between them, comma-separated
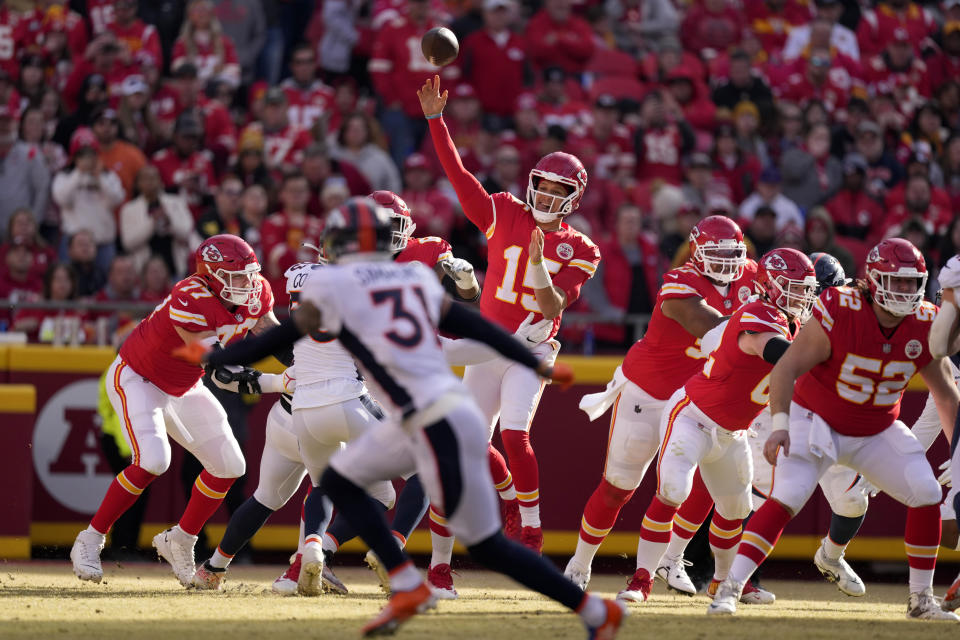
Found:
297,261 -> 461,417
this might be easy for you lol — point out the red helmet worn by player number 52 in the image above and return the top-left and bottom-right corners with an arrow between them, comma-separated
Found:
867,238 -> 927,316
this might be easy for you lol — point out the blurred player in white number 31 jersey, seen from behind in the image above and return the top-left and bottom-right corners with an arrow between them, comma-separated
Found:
175,198 -> 625,638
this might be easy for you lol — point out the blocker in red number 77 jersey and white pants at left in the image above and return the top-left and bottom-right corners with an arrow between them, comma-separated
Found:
70,235 -> 278,586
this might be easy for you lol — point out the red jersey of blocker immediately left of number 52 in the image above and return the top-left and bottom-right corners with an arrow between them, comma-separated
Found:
684,301 -> 794,431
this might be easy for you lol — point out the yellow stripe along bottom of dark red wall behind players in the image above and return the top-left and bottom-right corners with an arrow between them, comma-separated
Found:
26,522 -> 960,562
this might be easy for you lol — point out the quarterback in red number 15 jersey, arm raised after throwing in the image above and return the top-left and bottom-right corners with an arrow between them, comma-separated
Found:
418,76 -> 600,551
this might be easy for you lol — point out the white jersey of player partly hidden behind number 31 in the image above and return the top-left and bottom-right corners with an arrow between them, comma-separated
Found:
283,262 -> 367,410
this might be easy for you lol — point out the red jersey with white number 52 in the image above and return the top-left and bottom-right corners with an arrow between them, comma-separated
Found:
793,287 -> 937,437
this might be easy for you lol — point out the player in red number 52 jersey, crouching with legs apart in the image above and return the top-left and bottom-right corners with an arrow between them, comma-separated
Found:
708,238 -> 960,621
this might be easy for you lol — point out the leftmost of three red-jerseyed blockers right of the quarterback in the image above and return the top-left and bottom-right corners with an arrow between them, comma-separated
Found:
566,216 -> 757,595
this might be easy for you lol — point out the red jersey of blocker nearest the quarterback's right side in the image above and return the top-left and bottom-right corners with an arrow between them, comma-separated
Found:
623,260 -> 757,400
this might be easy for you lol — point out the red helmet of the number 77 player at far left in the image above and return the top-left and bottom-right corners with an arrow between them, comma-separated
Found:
196,233 -> 263,313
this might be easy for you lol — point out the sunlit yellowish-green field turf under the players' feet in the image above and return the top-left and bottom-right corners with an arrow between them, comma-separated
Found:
0,563 -> 960,640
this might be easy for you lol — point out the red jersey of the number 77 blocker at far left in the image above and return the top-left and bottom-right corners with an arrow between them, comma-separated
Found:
120,276 -> 273,396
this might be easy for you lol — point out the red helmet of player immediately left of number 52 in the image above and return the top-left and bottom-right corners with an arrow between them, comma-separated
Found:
754,249 -> 818,322
